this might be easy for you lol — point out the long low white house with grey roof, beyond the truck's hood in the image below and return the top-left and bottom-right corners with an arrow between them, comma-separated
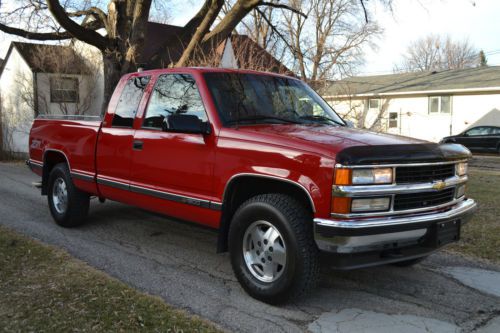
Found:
320,66 -> 500,142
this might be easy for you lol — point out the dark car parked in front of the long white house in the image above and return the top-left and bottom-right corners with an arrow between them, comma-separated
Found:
441,126 -> 500,154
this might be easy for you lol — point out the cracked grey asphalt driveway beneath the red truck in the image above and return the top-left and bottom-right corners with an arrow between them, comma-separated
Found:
0,163 -> 500,333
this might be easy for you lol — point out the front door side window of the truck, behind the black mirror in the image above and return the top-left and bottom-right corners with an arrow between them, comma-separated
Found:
142,74 -> 207,130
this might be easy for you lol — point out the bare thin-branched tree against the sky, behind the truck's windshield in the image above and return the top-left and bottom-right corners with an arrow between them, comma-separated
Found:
284,0 -> 382,81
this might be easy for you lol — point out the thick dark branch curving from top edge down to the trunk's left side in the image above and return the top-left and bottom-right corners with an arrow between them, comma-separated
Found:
47,0 -> 110,50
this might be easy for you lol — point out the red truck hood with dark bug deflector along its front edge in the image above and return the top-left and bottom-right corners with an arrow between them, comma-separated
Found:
229,124 -> 470,164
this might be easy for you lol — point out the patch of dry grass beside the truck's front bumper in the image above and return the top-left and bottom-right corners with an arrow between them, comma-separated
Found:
447,169 -> 500,264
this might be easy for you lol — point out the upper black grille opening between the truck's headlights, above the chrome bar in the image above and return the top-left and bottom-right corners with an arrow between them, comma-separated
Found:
396,164 -> 455,184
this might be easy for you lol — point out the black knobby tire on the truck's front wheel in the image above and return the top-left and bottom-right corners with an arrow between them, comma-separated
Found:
229,194 -> 319,304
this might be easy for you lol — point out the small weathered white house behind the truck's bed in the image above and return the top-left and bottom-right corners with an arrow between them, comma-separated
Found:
0,42 -> 99,154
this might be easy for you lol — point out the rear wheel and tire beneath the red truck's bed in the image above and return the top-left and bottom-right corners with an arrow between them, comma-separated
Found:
47,163 -> 90,228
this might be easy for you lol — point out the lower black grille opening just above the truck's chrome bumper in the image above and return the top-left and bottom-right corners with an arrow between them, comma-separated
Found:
394,188 -> 455,211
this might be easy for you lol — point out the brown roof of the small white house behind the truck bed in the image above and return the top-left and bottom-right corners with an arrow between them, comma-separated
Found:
5,42 -> 90,74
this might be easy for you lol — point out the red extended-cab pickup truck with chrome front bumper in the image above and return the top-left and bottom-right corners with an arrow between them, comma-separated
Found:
27,68 -> 476,303
